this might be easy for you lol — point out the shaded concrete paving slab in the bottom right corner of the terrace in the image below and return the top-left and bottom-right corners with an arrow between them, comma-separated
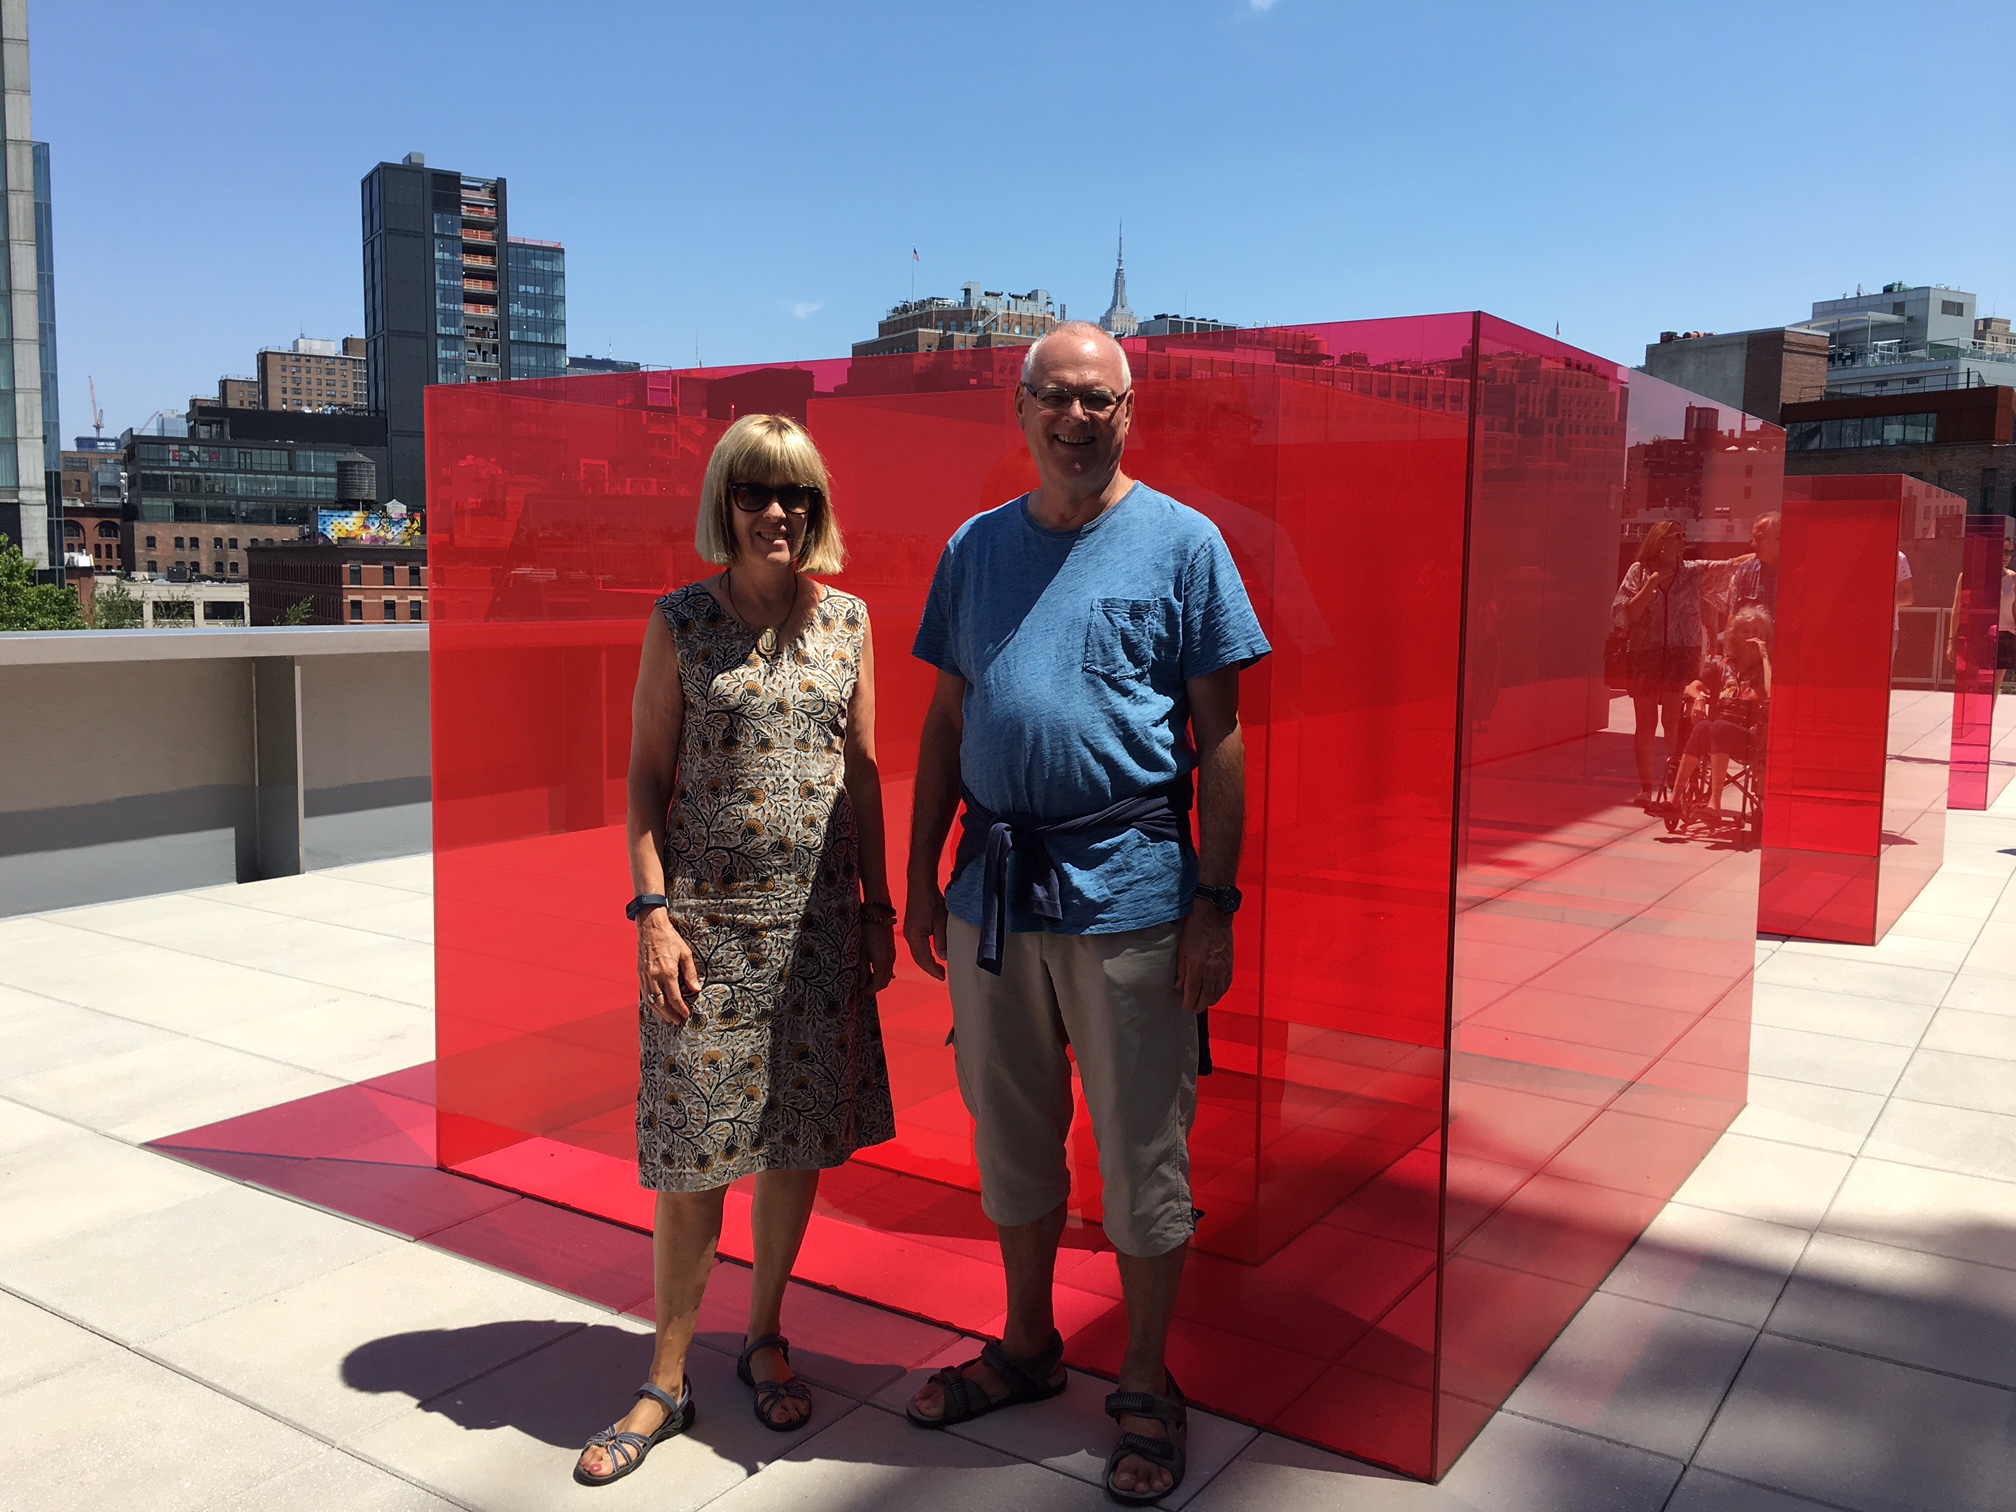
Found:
1695,1333 -> 2016,1512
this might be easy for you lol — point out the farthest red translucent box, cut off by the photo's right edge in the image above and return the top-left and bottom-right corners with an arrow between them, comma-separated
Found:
1945,514 -> 2016,808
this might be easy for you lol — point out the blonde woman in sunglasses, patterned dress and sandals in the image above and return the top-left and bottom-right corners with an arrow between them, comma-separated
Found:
575,415 -> 895,1486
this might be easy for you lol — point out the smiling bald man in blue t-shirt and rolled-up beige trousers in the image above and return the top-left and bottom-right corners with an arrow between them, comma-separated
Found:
903,321 -> 1268,1502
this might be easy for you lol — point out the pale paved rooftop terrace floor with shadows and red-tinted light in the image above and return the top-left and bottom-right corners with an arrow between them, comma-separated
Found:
0,788 -> 2016,1512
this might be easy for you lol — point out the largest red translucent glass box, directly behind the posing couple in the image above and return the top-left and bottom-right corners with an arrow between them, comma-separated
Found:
427,312 -> 1766,1476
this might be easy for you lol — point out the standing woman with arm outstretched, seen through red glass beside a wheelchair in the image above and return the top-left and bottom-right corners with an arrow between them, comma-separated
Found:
1611,520 -> 1752,806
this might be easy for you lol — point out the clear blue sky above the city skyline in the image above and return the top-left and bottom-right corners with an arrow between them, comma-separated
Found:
30,0 -> 2016,435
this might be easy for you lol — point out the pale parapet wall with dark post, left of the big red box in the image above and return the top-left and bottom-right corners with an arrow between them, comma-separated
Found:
0,625 -> 433,915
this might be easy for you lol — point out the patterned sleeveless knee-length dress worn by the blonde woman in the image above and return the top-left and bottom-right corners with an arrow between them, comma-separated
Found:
637,583 -> 895,1191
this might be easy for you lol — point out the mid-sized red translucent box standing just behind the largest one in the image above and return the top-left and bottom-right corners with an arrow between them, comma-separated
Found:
1758,474 -> 1964,946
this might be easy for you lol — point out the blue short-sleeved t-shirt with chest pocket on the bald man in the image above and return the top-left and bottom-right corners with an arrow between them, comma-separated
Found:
913,484 -> 1268,935
